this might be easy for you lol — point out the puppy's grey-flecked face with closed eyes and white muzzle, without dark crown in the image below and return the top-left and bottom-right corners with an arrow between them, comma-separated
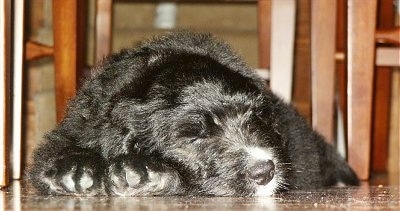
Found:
164,82 -> 286,196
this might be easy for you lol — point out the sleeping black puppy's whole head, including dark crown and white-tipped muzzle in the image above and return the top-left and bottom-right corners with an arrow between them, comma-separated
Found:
138,56 -> 289,196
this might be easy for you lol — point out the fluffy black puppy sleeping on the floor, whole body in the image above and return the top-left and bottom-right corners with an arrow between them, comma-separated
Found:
28,32 -> 358,196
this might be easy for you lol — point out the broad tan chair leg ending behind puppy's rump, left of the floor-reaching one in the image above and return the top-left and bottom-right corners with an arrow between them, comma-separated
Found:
311,1 -> 336,145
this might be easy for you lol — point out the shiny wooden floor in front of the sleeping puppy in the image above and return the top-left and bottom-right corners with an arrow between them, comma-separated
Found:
0,181 -> 400,211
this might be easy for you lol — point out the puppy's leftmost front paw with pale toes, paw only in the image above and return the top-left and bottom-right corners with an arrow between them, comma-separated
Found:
42,154 -> 104,196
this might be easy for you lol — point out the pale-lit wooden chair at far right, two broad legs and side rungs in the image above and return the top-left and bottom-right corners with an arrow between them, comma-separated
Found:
312,0 -> 400,180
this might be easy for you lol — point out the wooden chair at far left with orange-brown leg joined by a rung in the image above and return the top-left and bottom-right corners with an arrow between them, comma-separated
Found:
0,0 -> 86,186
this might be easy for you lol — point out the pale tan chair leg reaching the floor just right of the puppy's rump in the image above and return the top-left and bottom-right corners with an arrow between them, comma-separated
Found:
347,0 -> 377,180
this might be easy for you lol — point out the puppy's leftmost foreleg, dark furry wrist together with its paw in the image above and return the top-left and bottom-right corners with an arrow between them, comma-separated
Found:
27,134 -> 105,196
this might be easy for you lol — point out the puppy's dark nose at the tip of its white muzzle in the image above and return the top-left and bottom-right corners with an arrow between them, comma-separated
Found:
247,160 -> 275,185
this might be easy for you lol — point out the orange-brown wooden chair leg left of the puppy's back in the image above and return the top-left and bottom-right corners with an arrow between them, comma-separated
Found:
53,0 -> 87,122
